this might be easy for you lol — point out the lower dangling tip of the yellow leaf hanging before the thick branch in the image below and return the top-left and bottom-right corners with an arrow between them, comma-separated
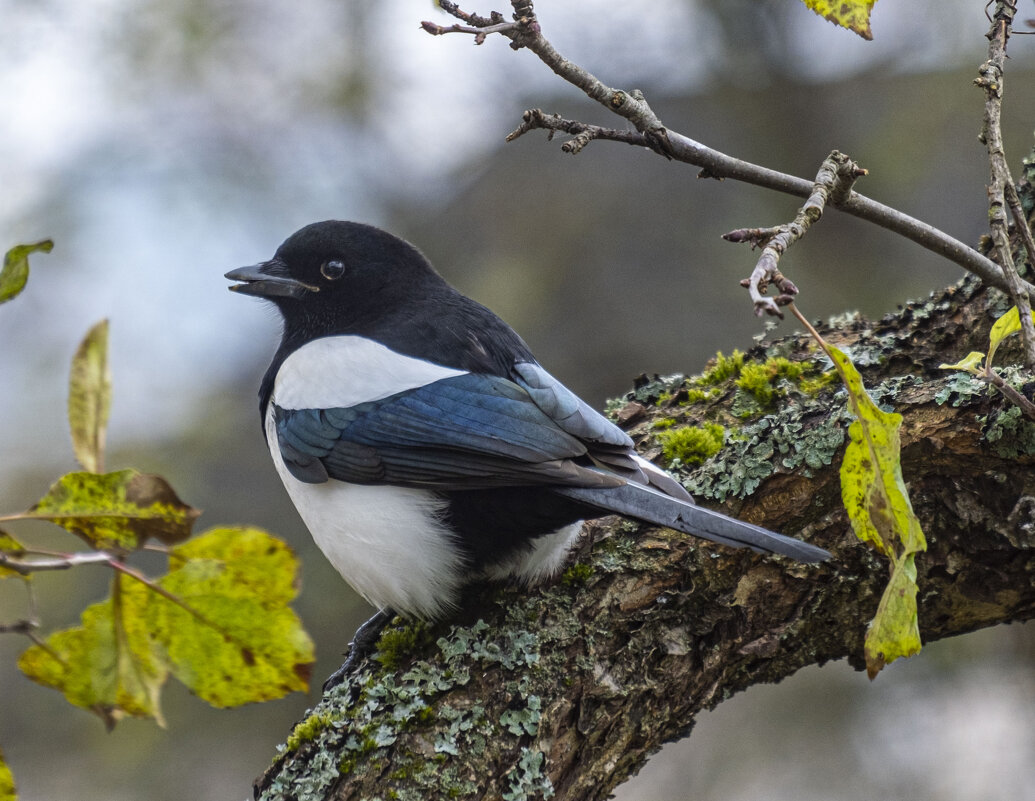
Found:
863,553 -> 920,679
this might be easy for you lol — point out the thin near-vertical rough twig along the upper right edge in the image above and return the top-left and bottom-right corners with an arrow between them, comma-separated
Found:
974,0 -> 1035,369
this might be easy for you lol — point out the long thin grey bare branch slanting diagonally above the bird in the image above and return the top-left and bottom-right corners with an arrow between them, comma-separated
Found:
418,0 -> 1035,297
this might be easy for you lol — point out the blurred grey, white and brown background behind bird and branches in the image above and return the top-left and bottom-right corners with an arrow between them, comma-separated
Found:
0,0 -> 1035,801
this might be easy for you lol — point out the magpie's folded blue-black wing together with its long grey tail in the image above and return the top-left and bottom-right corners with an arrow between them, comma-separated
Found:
273,362 -> 829,562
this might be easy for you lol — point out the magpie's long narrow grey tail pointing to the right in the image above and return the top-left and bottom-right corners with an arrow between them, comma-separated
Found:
554,483 -> 830,562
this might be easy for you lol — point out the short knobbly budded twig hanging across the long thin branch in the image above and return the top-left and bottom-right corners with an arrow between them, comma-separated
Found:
722,150 -> 866,320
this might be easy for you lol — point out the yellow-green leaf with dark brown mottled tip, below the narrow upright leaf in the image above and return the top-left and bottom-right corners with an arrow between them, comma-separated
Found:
22,470 -> 201,551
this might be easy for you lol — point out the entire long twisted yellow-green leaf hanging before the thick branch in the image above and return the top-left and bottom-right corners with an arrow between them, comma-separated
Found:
828,346 -> 927,678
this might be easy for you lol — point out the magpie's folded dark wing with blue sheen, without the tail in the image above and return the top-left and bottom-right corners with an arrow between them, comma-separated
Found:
273,374 -> 624,490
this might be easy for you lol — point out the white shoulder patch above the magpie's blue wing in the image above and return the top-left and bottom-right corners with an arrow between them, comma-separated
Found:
271,335 -> 465,409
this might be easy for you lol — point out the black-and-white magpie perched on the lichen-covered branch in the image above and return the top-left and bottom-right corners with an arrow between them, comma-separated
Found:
226,220 -> 830,689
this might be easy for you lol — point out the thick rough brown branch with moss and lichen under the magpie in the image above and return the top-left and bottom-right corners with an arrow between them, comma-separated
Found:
256,279 -> 1035,801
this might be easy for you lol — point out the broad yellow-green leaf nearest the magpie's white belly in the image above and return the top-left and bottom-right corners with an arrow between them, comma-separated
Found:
150,528 -> 315,707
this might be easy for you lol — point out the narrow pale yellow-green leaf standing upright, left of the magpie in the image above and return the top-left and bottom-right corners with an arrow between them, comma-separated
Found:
68,320 -> 112,473
